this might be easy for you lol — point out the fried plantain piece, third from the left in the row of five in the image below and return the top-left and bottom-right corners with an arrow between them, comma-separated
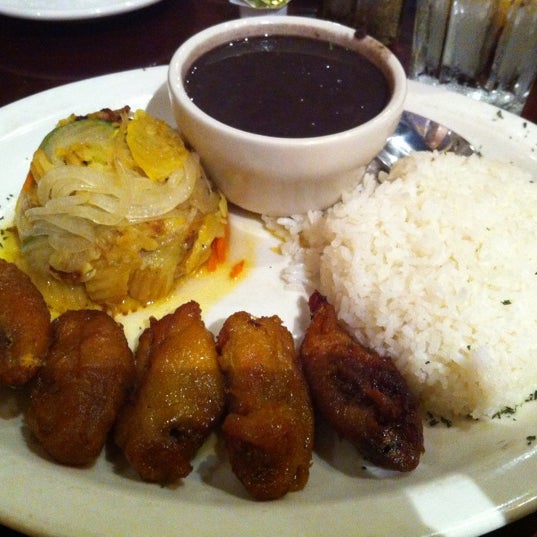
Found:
115,301 -> 224,484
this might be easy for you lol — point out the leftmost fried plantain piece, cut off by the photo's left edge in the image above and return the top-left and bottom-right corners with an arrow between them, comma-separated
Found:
0,259 -> 51,386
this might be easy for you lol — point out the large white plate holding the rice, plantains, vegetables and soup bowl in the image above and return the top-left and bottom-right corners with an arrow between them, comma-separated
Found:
0,67 -> 537,537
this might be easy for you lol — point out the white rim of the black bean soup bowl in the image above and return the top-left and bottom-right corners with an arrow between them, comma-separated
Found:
167,15 -> 407,147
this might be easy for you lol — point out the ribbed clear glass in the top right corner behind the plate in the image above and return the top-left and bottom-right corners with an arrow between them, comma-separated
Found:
410,0 -> 537,114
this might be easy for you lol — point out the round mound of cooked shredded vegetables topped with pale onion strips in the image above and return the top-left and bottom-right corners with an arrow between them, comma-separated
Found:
15,107 -> 227,310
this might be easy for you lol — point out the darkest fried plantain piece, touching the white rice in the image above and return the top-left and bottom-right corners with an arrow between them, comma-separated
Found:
300,292 -> 424,472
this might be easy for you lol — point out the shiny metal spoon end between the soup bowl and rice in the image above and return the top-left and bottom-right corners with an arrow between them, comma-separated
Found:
367,111 -> 477,174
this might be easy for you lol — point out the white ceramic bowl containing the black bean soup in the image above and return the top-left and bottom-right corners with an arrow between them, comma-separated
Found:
168,16 -> 407,216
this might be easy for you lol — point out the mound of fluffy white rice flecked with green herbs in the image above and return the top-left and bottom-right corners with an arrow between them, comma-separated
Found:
273,153 -> 537,418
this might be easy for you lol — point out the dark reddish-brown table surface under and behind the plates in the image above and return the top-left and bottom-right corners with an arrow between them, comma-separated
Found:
0,0 -> 537,537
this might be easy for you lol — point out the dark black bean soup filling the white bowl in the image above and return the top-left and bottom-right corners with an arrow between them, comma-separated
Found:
185,35 -> 390,138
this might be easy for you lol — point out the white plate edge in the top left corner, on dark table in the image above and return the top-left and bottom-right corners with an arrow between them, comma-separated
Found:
0,0 -> 160,20
